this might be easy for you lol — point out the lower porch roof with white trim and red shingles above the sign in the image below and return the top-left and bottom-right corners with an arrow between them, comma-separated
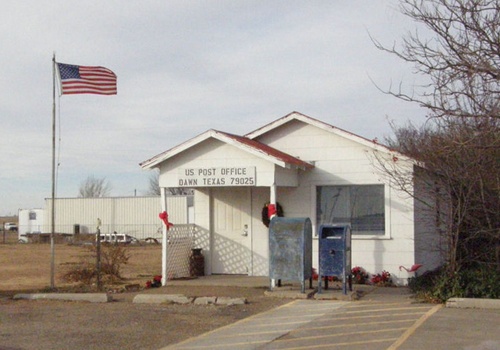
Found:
139,129 -> 314,170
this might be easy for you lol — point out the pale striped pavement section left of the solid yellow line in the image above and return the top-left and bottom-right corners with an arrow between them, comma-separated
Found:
162,296 -> 440,350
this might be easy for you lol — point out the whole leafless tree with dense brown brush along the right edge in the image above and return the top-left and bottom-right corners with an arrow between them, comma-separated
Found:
374,0 -> 500,272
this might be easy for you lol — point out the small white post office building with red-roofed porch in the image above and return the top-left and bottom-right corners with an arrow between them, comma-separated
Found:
140,112 -> 442,284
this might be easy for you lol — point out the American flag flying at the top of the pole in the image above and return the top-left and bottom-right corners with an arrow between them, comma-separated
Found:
57,63 -> 116,95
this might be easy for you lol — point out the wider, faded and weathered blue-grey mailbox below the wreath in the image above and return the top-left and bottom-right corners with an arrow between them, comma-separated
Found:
269,217 -> 312,293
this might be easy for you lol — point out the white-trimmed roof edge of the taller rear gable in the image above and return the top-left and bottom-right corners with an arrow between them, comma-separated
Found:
245,112 -> 393,152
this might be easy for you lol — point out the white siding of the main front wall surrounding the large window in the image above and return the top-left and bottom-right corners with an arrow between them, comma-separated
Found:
259,121 -> 415,284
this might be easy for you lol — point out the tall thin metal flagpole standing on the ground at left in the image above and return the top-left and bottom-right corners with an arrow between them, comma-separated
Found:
50,53 -> 56,289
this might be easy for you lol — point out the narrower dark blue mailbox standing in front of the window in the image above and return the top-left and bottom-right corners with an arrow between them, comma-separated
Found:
318,224 -> 352,294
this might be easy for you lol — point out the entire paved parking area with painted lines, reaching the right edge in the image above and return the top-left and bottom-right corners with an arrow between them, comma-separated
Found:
161,282 -> 500,350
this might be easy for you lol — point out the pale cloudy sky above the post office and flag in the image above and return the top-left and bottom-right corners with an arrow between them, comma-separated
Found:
0,0 -> 425,216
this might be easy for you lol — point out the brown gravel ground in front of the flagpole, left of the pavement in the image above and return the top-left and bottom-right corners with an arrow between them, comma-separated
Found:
0,286 -> 289,350
